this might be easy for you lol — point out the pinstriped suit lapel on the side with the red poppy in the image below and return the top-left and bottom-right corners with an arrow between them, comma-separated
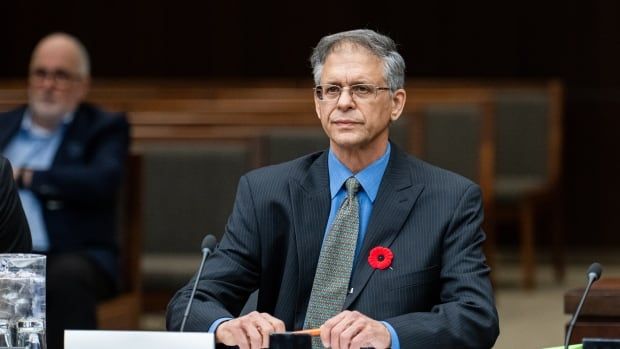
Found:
344,146 -> 424,309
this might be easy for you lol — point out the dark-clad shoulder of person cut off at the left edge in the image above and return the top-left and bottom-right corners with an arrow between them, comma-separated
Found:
0,156 -> 32,253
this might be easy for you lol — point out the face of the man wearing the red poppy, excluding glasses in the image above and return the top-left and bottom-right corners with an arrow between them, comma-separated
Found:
315,44 -> 405,153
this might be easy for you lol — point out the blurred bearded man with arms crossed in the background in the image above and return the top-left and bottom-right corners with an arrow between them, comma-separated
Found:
0,33 -> 129,349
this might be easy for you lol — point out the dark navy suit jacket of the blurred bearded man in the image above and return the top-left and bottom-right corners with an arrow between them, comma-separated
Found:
0,104 -> 129,278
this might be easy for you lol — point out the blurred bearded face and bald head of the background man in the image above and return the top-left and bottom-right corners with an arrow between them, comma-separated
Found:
28,38 -> 88,124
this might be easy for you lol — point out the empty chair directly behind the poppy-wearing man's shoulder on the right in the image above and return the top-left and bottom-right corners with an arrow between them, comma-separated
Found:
410,93 -> 496,274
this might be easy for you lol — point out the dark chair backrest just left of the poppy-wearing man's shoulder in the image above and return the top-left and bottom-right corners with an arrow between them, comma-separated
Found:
143,143 -> 254,251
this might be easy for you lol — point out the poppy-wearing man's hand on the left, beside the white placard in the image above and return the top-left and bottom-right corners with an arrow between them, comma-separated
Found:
215,311 -> 286,349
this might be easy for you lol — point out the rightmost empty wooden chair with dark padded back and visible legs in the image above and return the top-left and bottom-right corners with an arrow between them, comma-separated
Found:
495,81 -> 564,288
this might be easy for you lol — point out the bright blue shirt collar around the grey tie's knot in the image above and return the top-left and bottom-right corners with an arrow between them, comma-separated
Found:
327,143 -> 391,202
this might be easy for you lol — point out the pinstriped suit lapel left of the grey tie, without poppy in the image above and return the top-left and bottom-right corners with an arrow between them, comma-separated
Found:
290,152 -> 331,307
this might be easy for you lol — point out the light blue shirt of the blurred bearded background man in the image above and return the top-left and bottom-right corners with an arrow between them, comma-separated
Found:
4,111 -> 73,252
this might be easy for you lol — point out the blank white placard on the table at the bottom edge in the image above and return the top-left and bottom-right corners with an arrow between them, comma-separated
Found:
65,330 -> 215,349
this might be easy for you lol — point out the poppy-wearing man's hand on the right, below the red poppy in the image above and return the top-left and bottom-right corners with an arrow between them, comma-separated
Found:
321,310 -> 391,349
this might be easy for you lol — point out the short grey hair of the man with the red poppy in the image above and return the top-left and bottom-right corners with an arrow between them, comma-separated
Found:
310,29 -> 405,92
